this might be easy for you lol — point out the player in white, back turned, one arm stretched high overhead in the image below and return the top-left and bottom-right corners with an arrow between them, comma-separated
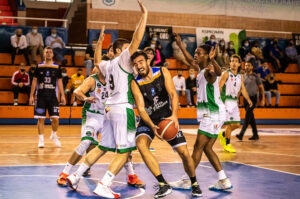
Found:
67,0 -> 148,198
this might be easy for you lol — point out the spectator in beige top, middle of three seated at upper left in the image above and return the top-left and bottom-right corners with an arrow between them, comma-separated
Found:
26,26 -> 44,63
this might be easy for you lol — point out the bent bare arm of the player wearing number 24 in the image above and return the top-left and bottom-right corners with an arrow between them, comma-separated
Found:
74,77 -> 97,103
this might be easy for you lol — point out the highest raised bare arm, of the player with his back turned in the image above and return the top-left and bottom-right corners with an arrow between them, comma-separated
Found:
128,0 -> 148,55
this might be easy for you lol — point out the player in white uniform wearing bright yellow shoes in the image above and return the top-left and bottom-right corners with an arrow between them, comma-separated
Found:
218,55 -> 253,153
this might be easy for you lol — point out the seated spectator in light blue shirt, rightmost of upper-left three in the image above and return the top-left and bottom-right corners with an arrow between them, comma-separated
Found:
46,28 -> 67,66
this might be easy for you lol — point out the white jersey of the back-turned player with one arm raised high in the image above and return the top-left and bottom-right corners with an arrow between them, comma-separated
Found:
99,48 -> 134,105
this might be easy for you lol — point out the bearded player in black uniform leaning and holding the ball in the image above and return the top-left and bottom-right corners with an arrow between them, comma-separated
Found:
131,51 -> 202,198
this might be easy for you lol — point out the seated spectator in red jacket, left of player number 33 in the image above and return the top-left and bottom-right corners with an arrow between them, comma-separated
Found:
11,63 -> 30,106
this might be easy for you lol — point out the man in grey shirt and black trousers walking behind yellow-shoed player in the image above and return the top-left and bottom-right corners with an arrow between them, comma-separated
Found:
236,62 -> 265,140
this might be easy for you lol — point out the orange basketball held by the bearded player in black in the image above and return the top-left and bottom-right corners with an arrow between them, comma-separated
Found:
157,119 -> 178,141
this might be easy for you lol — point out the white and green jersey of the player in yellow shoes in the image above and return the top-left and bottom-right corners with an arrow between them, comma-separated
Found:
221,70 -> 242,102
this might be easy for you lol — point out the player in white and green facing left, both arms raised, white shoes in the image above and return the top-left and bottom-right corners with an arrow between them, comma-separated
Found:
170,35 -> 232,190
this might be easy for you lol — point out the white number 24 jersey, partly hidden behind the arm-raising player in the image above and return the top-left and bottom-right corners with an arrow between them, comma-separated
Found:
82,74 -> 109,123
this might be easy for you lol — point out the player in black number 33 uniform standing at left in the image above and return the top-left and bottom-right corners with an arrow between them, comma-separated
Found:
29,47 -> 66,148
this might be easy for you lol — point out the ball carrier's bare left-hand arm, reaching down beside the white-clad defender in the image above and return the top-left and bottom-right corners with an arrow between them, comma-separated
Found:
131,81 -> 162,139
